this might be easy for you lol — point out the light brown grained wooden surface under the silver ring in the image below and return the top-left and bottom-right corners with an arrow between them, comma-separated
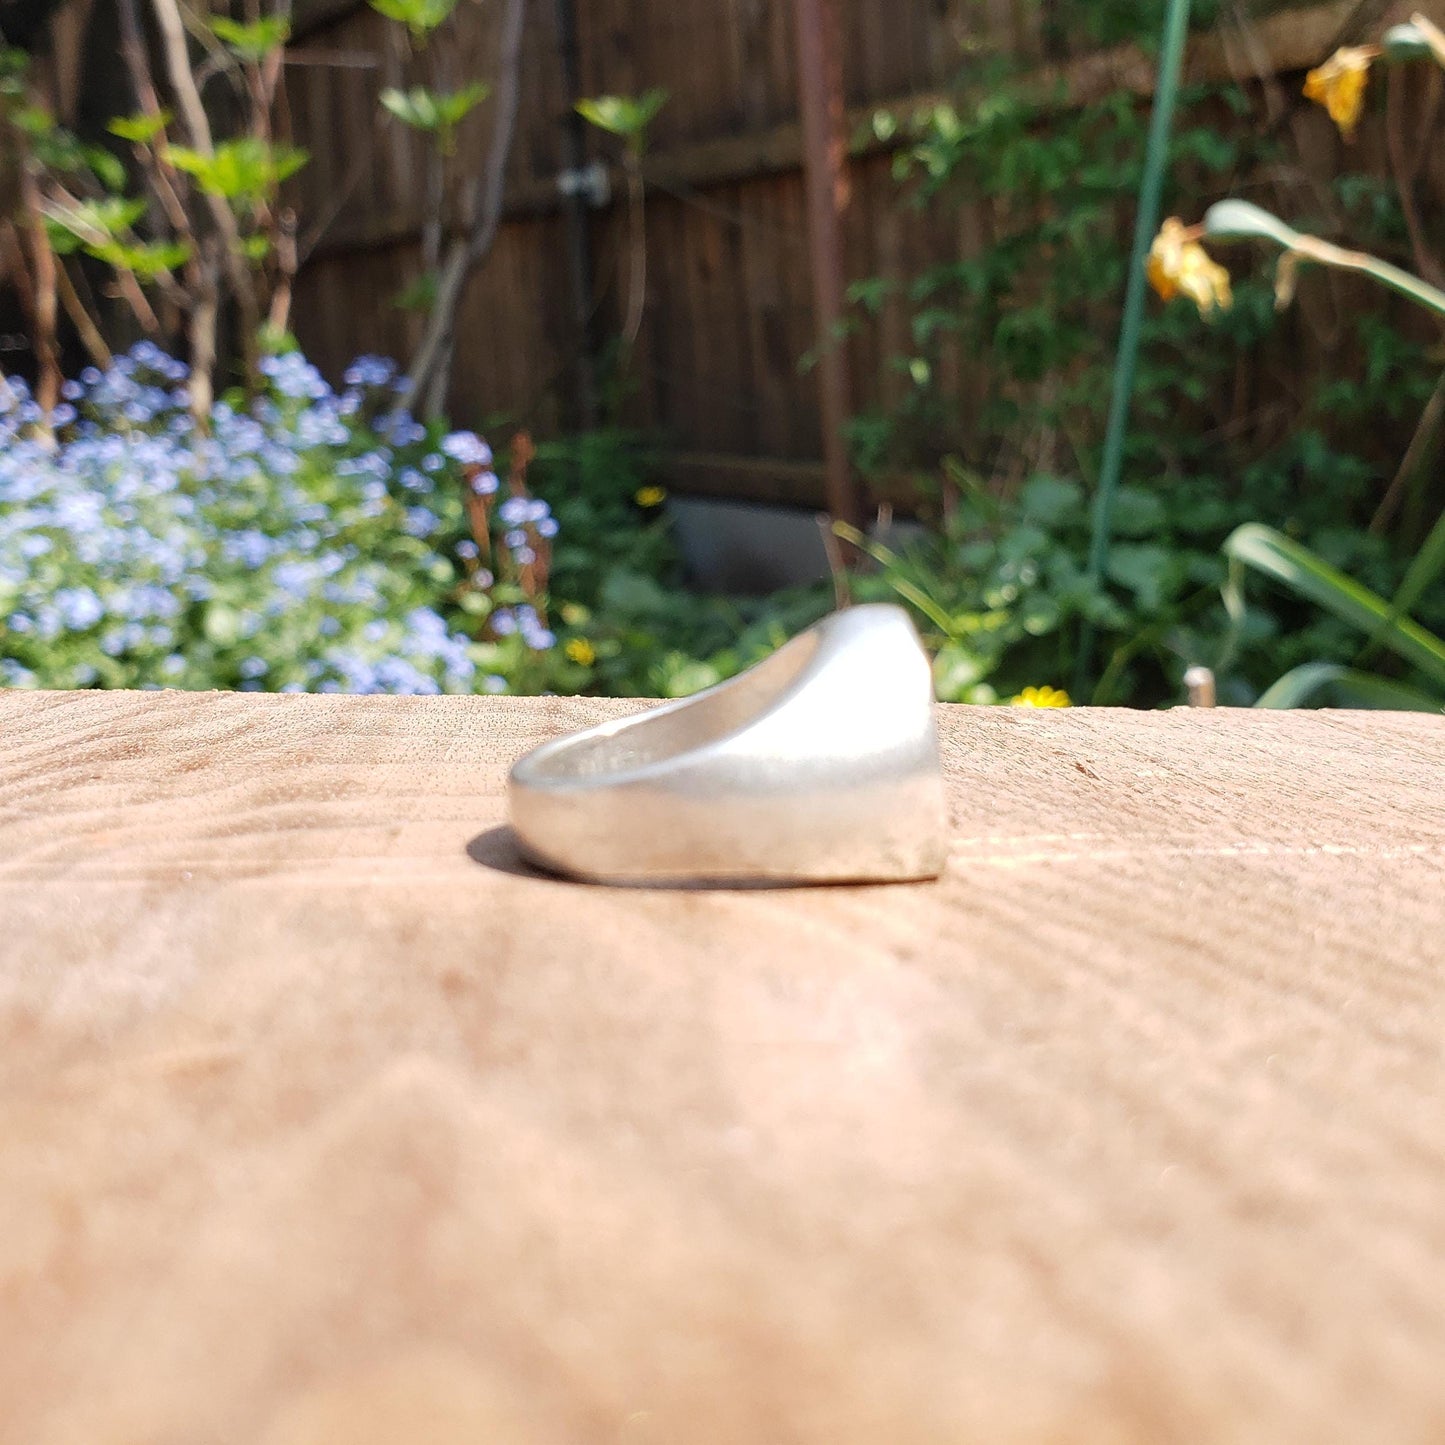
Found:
0,694 -> 1445,1445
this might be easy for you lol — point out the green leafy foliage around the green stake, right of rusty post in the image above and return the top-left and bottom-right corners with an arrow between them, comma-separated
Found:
851,9 -> 1445,704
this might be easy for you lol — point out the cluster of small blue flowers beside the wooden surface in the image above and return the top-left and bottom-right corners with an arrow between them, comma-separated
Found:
0,342 -> 556,692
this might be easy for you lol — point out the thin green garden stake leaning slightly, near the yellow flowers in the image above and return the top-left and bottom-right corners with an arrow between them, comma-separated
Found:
1074,0 -> 1189,701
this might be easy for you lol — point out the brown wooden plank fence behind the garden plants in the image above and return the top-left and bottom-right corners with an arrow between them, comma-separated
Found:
288,0 -> 1445,504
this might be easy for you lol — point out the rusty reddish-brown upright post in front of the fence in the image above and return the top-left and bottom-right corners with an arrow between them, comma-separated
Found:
793,0 -> 863,526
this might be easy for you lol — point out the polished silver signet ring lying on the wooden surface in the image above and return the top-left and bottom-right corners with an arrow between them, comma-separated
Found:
510,604 -> 946,884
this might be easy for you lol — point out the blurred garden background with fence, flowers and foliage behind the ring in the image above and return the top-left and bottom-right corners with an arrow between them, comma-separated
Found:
0,0 -> 1445,709
